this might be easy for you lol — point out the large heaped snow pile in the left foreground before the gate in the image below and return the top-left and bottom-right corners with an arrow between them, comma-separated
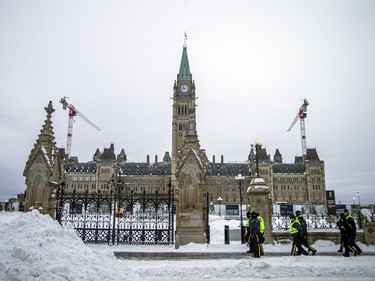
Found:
0,211 -> 131,281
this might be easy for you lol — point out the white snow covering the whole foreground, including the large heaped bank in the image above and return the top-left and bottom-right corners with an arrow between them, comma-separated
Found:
0,211 -> 375,281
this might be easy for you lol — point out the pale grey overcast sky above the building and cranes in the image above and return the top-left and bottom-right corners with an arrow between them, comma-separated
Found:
0,0 -> 375,203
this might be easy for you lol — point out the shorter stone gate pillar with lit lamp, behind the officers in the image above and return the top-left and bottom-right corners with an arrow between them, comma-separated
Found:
246,178 -> 273,244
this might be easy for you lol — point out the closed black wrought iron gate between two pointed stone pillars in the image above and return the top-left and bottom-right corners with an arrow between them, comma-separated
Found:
56,184 -> 175,245
